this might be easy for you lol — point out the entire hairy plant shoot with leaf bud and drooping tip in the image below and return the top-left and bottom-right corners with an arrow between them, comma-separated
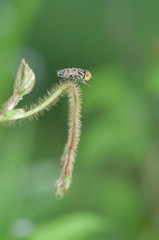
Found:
0,59 -> 81,199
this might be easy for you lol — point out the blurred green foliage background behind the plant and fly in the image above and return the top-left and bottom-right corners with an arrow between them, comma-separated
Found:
0,0 -> 159,240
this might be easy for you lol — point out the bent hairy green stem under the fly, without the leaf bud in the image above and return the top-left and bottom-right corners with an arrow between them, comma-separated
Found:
0,81 -> 81,199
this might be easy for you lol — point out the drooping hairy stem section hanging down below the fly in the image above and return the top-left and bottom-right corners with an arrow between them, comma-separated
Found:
55,87 -> 81,199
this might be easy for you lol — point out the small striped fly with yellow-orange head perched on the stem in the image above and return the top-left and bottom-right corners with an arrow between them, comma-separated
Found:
57,68 -> 92,87
